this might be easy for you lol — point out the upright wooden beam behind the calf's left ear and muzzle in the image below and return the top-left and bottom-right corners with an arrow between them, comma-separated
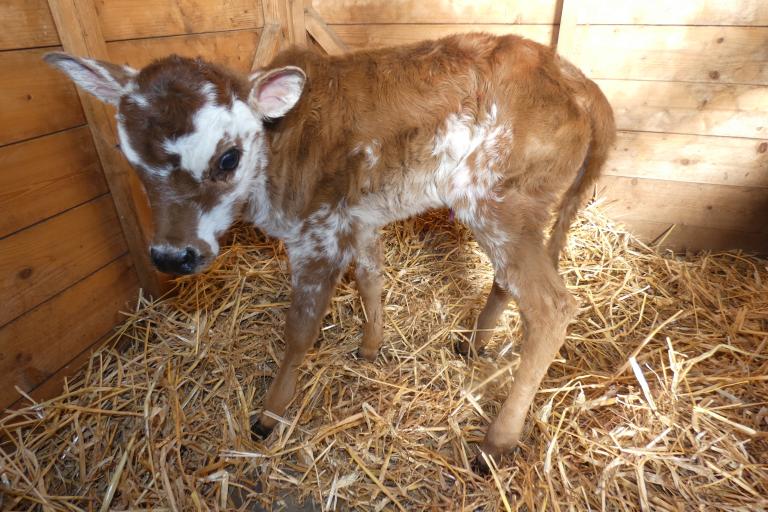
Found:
48,0 -> 162,297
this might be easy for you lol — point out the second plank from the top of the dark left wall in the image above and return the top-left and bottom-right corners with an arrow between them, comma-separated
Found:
0,48 -> 85,146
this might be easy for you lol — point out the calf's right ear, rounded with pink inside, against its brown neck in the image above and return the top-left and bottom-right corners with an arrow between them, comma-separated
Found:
248,66 -> 307,119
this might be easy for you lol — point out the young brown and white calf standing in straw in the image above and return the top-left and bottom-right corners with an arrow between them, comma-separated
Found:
46,34 -> 615,468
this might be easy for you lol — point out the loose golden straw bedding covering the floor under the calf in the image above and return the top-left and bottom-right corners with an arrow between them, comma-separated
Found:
0,207 -> 768,510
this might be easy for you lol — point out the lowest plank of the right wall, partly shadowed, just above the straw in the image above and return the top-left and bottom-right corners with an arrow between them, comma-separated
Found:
623,219 -> 768,255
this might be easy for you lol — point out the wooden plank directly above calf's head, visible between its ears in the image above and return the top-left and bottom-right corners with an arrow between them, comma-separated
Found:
107,30 -> 259,73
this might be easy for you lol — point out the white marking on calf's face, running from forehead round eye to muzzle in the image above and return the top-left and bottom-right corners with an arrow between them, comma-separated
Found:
163,84 -> 265,254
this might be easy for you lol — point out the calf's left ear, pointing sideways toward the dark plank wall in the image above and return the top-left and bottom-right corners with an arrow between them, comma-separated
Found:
43,52 -> 137,105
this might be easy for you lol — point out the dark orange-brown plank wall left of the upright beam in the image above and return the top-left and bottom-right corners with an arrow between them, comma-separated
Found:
0,0 -> 138,408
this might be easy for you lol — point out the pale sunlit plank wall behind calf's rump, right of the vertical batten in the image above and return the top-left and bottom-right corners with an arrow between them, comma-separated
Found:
559,0 -> 768,253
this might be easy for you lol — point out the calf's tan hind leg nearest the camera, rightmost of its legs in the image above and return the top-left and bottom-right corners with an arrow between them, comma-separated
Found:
480,237 -> 576,467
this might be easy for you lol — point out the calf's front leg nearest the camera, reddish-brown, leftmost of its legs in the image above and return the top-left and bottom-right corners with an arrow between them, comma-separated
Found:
251,254 -> 342,439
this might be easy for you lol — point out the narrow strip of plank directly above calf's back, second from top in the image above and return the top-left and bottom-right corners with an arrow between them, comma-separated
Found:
331,24 -> 552,50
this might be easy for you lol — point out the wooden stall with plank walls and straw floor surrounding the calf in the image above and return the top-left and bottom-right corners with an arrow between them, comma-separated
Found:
0,0 -> 768,510
